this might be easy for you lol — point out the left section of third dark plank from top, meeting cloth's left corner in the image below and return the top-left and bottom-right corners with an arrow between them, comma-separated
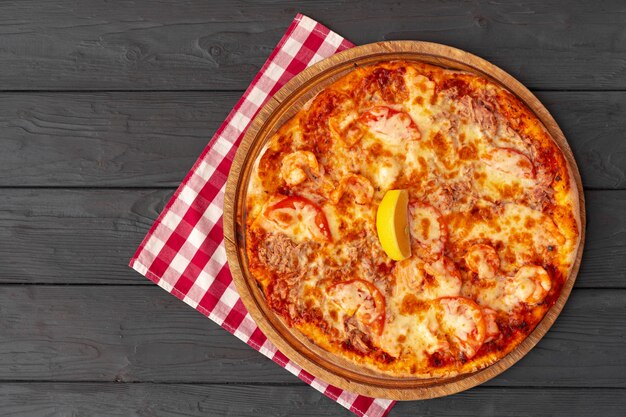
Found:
0,189 -> 173,285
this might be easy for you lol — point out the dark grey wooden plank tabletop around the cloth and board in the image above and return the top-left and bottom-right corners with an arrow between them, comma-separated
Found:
0,0 -> 626,417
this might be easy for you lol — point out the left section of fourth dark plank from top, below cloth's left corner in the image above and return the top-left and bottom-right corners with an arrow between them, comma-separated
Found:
0,286 -> 298,385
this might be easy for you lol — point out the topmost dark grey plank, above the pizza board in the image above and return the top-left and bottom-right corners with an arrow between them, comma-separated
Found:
0,0 -> 626,90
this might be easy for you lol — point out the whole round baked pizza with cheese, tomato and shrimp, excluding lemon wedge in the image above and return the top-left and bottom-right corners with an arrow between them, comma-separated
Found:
245,61 -> 581,378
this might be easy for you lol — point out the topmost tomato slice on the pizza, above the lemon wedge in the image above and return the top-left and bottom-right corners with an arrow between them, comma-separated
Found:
359,106 -> 422,144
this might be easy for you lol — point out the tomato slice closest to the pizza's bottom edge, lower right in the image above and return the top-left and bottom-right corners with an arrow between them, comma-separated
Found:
436,297 -> 486,359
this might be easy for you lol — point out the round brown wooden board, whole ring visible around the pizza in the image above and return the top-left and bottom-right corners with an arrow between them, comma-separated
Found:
224,41 -> 585,400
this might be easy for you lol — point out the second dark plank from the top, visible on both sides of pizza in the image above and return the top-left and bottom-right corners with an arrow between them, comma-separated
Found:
0,92 -> 626,189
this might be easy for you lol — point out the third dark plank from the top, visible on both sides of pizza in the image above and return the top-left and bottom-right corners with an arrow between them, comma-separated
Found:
0,189 -> 626,288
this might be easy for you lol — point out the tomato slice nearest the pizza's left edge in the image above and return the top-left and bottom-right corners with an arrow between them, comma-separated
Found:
264,196 -> 332,242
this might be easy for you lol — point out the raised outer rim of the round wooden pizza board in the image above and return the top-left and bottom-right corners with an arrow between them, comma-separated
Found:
224,41 -> 586,400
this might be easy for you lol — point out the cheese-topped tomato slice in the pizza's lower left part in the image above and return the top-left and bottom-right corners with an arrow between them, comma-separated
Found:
326,278 -> 386,336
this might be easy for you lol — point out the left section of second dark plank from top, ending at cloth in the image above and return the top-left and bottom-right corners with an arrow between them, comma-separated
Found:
0,92 -> 234,187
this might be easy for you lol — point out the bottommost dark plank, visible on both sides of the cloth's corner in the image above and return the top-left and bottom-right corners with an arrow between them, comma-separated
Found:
0,383 -> 626,417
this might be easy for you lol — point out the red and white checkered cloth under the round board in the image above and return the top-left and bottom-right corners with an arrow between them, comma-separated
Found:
130,14 -> 394,417
